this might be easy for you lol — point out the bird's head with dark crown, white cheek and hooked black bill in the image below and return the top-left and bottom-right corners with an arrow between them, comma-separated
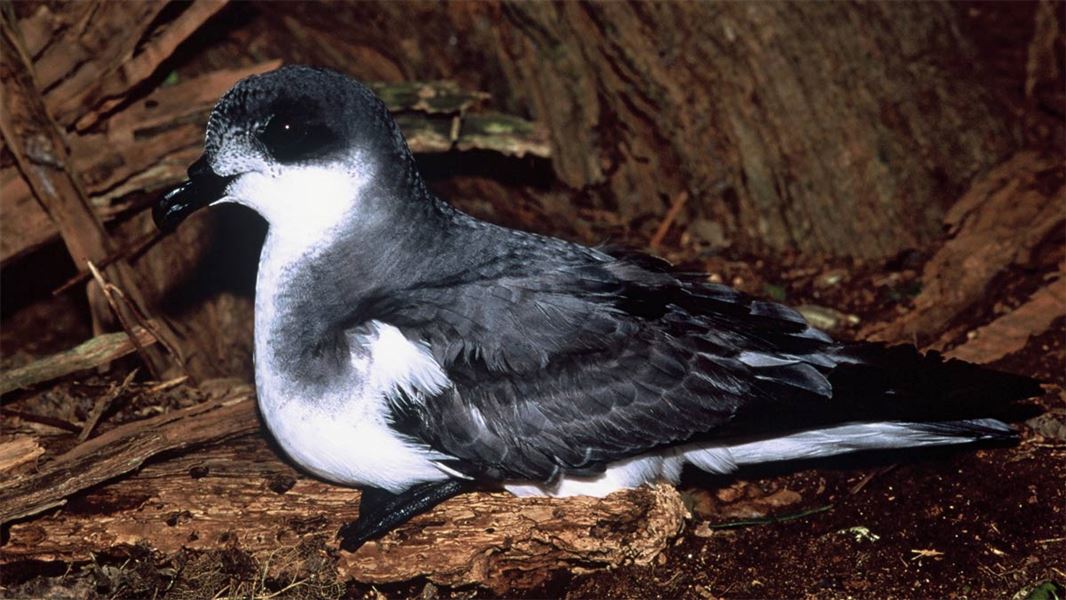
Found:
155,66 -> 421,239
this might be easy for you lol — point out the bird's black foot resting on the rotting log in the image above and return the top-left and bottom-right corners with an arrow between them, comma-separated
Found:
337,480 -> 470,552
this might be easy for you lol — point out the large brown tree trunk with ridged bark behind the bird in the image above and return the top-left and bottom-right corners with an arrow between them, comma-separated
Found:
255,2 -> 1014,257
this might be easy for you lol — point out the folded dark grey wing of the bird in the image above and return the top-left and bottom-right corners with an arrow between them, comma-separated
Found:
379,241 -> 844,481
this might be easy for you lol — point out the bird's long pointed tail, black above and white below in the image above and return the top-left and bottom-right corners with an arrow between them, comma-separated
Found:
684,343 -> 1043,473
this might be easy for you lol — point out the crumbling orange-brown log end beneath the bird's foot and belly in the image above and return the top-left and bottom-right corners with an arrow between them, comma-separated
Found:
339,484 -> 688,594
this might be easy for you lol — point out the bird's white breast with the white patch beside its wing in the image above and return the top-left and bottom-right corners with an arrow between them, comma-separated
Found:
255,234 -> 450,492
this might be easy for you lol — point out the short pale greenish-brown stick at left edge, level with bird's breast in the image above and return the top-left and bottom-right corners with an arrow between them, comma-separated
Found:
0,327 -> 156,394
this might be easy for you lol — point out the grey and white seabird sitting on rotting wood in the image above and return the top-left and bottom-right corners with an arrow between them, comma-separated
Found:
154,66 -> 1040,550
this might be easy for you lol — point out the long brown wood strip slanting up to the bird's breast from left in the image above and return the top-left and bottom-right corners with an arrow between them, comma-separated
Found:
0,390 -> 259,524
